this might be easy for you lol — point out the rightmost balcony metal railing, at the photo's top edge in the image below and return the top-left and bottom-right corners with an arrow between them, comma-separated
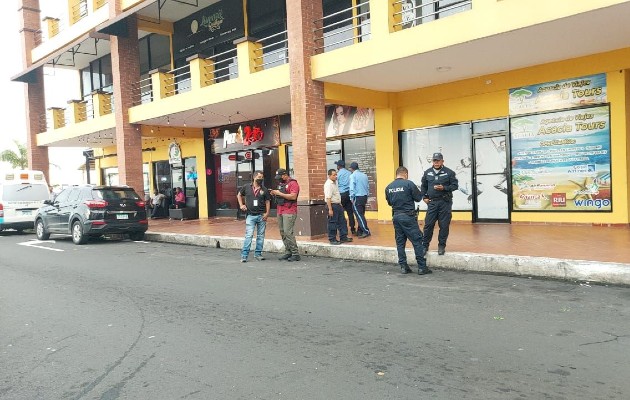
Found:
392,0 -> 472,29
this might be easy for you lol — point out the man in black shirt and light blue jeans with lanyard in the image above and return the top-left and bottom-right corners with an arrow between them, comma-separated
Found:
236,171 -> 271,262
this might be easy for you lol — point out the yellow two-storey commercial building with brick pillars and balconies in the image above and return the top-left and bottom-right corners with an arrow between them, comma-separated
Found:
14,0 -> 630,236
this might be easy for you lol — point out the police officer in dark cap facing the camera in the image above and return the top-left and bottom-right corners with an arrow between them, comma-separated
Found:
420,153 -> 459,255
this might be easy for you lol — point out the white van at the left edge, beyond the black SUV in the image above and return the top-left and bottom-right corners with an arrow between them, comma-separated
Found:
0,170 -> 50,232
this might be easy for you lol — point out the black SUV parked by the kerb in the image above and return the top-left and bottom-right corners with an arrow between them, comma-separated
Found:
35,185 -> 149,244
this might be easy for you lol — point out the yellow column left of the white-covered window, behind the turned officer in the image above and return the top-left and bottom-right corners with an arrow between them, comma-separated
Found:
374,95 -> 400,221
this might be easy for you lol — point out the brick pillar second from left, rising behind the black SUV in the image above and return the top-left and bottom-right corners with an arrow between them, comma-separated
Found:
111,13 -> 144,198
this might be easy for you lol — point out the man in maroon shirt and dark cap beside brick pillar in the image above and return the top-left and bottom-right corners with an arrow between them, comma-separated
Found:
270,168 -> 300,261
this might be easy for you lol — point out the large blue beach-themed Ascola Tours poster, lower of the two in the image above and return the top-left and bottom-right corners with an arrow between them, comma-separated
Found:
510,106 -> 612,211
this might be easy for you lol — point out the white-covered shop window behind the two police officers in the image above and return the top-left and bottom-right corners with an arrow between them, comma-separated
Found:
400,124 -> 473,211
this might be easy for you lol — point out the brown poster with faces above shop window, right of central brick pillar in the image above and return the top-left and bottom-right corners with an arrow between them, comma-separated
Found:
326,104 -> 374,138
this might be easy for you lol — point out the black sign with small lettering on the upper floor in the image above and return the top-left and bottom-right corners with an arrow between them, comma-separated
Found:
173,0 -> 245,59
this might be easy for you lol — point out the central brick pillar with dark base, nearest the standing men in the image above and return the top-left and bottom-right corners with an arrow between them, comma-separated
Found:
287,0 -> 328,237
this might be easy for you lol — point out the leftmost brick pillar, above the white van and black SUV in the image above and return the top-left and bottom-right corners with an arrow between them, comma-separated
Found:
18,0 -> 50,178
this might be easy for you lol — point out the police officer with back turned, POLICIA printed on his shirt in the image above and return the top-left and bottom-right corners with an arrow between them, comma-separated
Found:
385,167 -> 432,275
